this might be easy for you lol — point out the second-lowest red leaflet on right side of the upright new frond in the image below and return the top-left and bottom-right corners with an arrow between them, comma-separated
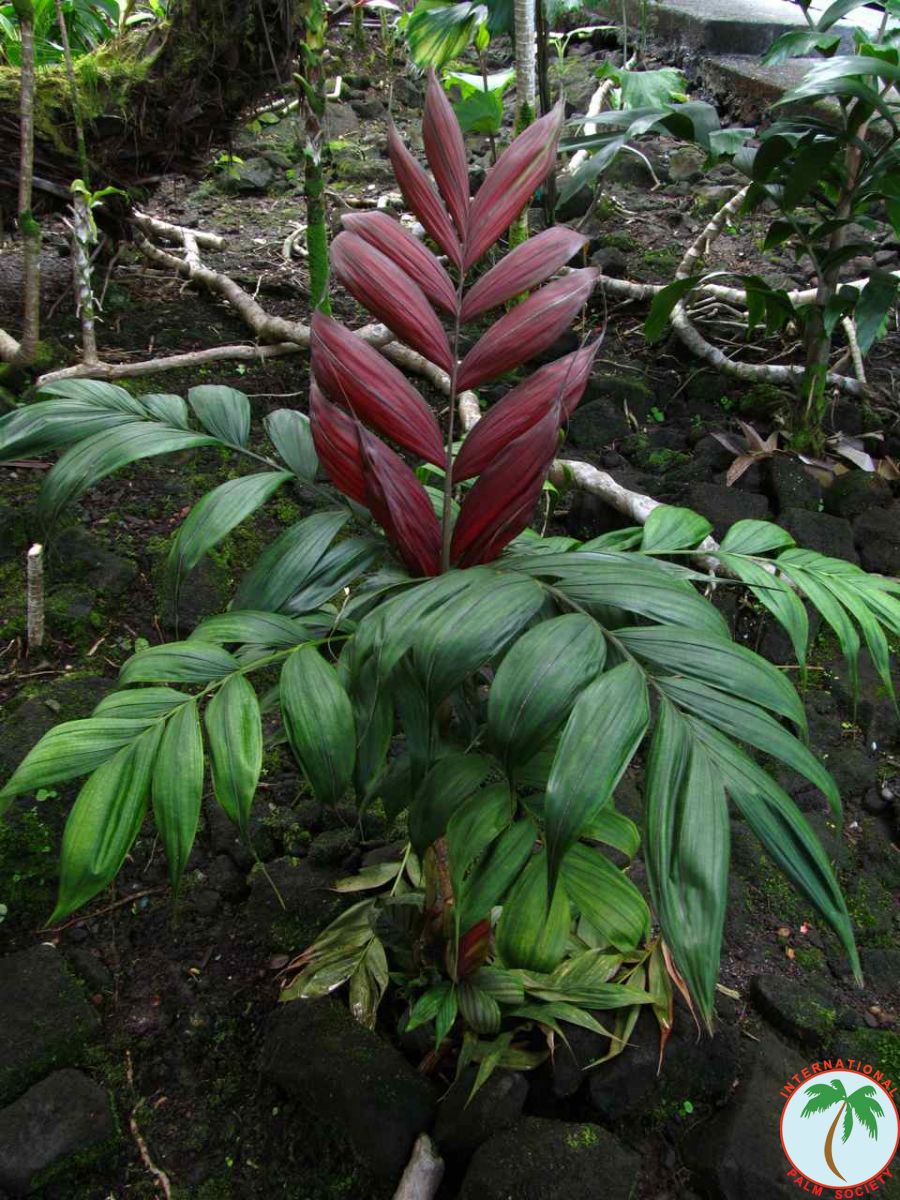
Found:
454,338 -> 602,484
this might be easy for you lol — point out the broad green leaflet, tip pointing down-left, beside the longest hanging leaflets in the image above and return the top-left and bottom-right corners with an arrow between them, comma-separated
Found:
544,662 -> 650,887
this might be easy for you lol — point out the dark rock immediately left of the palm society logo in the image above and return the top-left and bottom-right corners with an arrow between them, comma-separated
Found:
680,1032 -> 808,1200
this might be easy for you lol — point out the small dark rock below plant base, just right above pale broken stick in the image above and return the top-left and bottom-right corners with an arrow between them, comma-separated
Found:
434,1067 -> 528,1154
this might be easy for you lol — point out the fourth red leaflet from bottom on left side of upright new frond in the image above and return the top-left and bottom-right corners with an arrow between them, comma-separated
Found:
331,233 -> 452,371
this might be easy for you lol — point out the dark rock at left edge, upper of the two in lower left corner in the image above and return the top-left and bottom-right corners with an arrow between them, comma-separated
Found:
0,946 -> 100,1102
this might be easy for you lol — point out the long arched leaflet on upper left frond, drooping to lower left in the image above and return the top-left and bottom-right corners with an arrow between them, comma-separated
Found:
37,421 -> 216,522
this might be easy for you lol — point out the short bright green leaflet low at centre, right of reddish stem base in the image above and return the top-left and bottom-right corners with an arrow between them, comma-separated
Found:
497,850 -> 571,972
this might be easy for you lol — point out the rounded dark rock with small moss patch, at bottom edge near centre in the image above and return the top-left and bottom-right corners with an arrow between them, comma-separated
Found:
460,1117 -> 640,1200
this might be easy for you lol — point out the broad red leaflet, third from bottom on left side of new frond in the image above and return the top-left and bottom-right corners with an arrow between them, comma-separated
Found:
311,312 -> 445,467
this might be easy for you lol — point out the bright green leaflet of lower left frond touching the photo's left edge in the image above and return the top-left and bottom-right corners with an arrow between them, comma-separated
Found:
0,718 -> 150,811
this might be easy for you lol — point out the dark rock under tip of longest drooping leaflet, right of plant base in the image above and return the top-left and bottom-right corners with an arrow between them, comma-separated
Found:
588,1008 -> 738,1124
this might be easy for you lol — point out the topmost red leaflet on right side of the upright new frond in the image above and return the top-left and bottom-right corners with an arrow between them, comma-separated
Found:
465,101 -> 564,270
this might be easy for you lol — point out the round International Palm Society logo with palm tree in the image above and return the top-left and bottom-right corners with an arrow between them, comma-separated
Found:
781,1058 -> 900,1200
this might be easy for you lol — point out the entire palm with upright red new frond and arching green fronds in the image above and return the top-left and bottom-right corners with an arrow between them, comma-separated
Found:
0,77 -> 900,1084
